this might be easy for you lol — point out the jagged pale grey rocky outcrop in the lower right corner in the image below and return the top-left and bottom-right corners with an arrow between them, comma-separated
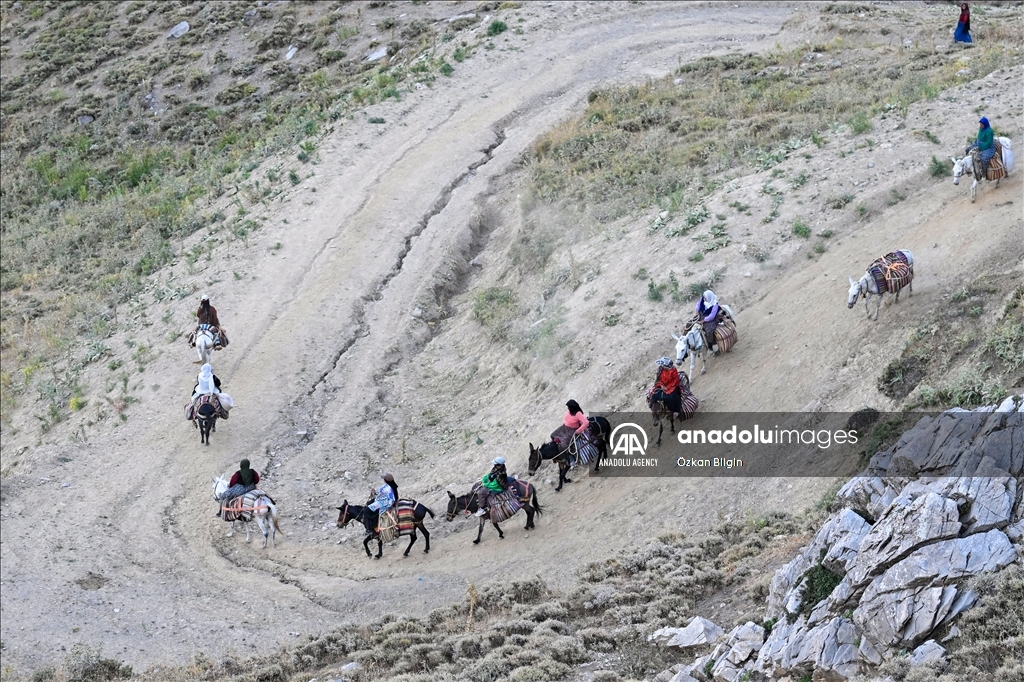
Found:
651,396 -> 1024,682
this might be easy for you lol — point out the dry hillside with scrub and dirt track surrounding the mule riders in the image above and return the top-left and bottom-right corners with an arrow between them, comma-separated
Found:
0,0 -> 1024,682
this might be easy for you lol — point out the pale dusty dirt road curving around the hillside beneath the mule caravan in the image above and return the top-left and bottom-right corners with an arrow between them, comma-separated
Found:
2,3 -> 1022,669
